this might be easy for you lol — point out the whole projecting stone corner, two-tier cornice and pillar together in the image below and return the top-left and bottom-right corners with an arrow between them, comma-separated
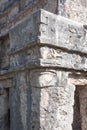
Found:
0,9 -> 87,130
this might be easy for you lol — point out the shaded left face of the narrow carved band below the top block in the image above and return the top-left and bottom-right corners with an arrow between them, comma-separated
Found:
10,46 -> 40,68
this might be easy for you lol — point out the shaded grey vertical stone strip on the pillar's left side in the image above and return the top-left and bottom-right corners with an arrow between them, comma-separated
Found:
9,72 -> 30,130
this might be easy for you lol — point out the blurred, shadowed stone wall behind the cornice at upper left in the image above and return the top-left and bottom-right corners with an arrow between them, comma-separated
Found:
0,0 -> 58,35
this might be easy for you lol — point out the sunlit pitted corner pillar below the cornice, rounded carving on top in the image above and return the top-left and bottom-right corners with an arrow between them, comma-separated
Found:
30,69 -> 75,130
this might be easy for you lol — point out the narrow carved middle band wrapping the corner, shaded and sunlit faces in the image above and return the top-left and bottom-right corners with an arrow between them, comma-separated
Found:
10,41 -> 87,71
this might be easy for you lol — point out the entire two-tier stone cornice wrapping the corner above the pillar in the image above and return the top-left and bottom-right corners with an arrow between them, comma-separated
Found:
0,9 -> 87,75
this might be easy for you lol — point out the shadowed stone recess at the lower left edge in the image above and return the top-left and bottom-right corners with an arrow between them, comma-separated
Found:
0,86 -> 10,130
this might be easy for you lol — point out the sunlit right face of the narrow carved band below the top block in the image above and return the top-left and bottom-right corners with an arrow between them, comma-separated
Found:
40,47 -> 87,71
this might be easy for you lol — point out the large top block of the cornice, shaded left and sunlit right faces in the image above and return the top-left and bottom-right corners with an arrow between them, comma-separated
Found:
9,9 -> 87,53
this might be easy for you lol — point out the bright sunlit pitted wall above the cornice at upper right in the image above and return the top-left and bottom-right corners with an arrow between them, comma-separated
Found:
63,0 -> 87,24
